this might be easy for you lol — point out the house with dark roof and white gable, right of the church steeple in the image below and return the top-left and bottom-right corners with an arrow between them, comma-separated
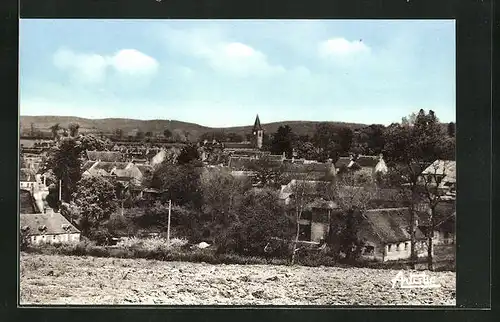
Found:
335,154 -> 388,178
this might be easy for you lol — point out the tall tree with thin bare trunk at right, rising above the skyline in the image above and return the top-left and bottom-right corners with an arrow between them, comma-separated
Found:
384,110 -> 450,265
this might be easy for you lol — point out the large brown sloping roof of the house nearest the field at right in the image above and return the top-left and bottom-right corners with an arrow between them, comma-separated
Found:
361,208 -> 425,243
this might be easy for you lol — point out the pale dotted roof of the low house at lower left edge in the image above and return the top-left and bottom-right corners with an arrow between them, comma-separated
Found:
20,212 -> 80,235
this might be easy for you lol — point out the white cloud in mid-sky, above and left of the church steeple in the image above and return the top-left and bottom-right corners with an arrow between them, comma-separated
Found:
164,28 -> 285,77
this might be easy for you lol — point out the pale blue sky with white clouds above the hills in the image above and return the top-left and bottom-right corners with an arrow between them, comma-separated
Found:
19,19 -> 455,127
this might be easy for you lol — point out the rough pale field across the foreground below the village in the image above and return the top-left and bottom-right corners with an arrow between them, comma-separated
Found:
20,253 -> 455,305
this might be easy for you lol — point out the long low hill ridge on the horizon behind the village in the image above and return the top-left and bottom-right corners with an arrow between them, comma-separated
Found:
20,115 -> 366,138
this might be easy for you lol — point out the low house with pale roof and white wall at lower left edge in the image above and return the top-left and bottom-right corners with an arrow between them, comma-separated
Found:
20,211 -> 80,244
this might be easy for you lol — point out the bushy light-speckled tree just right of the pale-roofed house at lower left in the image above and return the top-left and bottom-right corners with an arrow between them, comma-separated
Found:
73,176 -> 116,238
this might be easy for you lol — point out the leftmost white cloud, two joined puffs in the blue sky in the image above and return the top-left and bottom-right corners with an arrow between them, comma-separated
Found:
53,49 -> 159,83
